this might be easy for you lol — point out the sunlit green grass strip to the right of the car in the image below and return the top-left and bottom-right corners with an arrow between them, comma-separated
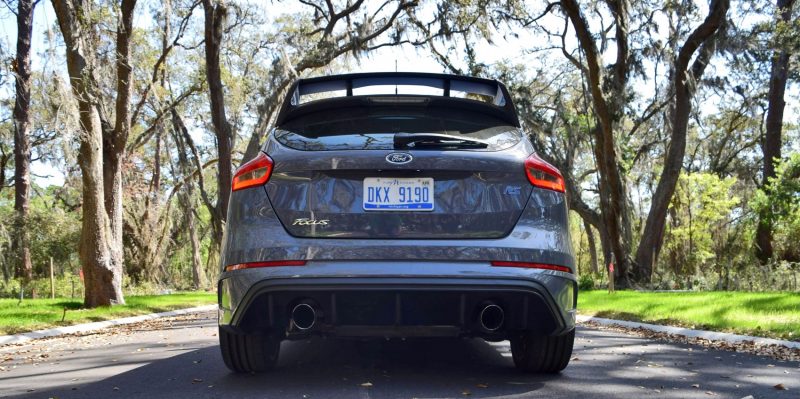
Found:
578,291 -> 800,341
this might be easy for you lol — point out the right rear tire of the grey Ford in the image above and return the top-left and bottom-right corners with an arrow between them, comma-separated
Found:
511,329 -> 575,373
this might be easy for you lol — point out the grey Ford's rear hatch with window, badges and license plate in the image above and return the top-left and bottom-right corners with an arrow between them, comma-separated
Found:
265,104 -> 532,239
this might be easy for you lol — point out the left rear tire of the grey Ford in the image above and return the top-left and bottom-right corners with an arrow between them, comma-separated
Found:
219,327 -> 281,373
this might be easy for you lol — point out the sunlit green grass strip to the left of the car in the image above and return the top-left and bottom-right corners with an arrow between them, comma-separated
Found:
0,292 -> 217,335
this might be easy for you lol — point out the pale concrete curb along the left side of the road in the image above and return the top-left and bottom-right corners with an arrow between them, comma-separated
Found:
0,305 -> 217,346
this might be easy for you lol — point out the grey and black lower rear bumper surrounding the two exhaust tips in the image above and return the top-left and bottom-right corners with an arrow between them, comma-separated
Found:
219,262 -> 577,339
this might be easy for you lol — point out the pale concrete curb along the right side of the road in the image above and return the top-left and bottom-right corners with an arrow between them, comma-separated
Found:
576,315 -> 800,349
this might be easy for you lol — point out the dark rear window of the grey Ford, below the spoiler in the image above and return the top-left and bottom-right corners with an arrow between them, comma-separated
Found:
273,107 -> 522,151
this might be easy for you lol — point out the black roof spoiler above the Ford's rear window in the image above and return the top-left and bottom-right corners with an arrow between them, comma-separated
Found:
275,72 -> 520,127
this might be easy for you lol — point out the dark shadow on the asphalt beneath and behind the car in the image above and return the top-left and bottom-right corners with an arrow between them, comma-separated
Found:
18,339 -> 566,398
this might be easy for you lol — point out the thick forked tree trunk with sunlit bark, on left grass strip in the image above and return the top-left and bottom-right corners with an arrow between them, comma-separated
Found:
53,0 -> 136,307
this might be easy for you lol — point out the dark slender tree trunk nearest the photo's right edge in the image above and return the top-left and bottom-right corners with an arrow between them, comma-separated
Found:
756,0 -> 795,263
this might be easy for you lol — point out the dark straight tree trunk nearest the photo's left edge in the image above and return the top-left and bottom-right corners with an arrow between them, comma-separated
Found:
12,0 -> 38,283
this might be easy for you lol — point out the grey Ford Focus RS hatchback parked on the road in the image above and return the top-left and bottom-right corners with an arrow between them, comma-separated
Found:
218,73 -> 577,372
